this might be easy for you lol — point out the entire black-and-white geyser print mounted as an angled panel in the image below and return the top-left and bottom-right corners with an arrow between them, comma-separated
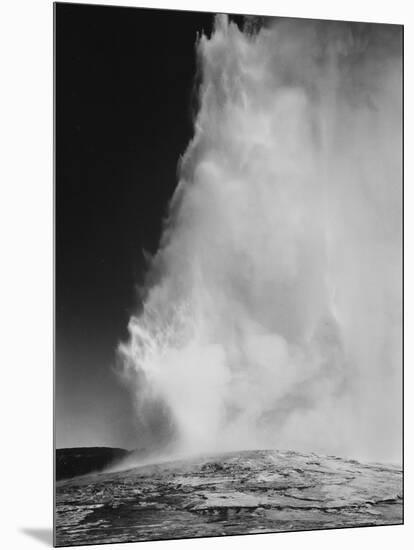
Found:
51,2 -> 404,547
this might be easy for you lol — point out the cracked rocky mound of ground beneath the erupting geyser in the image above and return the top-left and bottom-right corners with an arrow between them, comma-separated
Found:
56,451 -> 403,546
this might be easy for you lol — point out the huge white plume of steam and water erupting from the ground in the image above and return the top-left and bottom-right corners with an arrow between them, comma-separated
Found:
118,16 -> 402,461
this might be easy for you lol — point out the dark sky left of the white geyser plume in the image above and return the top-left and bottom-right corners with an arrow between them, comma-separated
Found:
56,4 -> 243,447
